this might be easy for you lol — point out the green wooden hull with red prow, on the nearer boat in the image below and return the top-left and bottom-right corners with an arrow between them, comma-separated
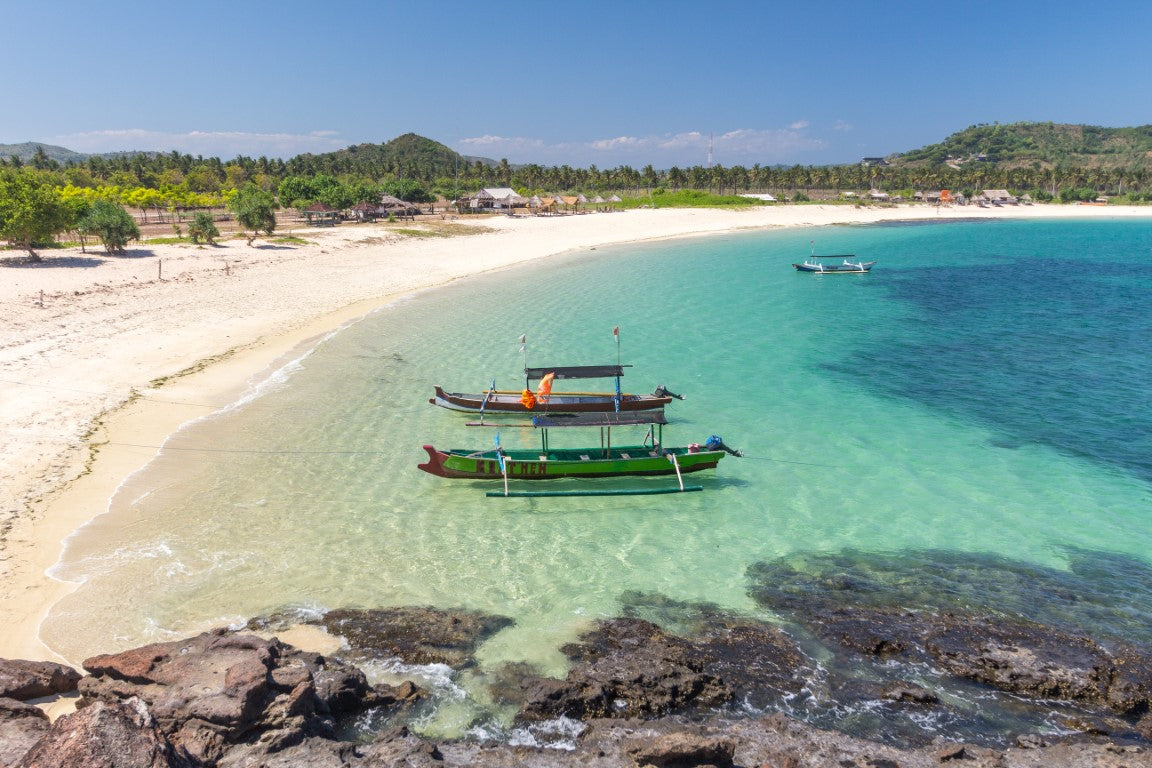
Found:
418,446 -> 725,480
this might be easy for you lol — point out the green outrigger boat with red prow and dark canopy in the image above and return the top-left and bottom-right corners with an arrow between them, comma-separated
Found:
418,410 -> 740,496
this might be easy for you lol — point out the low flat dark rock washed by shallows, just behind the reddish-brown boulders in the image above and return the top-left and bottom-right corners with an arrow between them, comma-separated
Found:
319,606 -> 513,669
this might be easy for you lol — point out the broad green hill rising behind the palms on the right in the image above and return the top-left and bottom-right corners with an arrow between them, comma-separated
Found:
888,123 -> 1152,168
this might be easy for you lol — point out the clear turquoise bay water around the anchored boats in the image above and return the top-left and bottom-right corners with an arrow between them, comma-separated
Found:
44,221 -> 1152,728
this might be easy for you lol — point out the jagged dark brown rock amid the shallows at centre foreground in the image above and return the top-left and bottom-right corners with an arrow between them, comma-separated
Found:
522,618 -> 814,718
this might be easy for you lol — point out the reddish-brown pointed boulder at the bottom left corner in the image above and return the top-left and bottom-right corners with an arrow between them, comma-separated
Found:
16,699 -> 191,768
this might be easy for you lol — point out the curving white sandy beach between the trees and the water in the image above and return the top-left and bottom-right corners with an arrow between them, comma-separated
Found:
0,205 -> 1152,659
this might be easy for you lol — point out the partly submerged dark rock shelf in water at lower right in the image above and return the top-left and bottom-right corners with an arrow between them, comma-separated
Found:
750,552 -> 1152,744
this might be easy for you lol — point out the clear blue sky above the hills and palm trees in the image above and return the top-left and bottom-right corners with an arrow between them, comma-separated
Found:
0,0 -> 1152,168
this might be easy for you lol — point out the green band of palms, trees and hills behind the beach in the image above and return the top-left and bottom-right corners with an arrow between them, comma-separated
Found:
0,123 -> 1152,253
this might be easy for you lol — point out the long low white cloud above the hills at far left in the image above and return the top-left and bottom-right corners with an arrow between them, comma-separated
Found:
46,128 -> 348,160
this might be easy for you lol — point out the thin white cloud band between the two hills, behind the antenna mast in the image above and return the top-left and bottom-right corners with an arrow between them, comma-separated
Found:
457,126 -> 827,168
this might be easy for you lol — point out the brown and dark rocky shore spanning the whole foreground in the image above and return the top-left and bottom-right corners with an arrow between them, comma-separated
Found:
0,600 -> 1152,768
